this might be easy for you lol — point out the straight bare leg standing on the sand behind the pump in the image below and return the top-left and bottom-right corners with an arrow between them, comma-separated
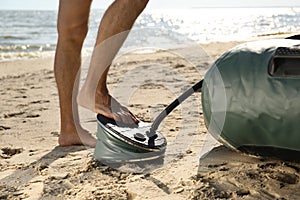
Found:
54,0 -> 96,146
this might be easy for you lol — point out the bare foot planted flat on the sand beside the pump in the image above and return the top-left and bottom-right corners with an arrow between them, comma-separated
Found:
58,126 -> 97,147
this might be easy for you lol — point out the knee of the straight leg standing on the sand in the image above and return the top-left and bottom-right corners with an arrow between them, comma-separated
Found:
57,22 -> 88,47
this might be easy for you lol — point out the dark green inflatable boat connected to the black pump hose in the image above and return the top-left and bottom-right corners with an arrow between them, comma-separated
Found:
202,36 -> 300,157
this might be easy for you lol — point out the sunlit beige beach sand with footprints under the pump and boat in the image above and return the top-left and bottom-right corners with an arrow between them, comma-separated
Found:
0,42 -> 300,200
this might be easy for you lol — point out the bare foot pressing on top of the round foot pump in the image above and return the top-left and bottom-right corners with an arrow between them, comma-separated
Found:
77,86 -> 139,125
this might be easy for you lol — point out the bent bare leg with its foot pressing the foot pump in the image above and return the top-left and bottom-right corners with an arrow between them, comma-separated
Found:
78,0 -> 148,124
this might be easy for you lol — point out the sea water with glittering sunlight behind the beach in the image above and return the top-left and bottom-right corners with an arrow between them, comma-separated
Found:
0,7 -> 300,61
